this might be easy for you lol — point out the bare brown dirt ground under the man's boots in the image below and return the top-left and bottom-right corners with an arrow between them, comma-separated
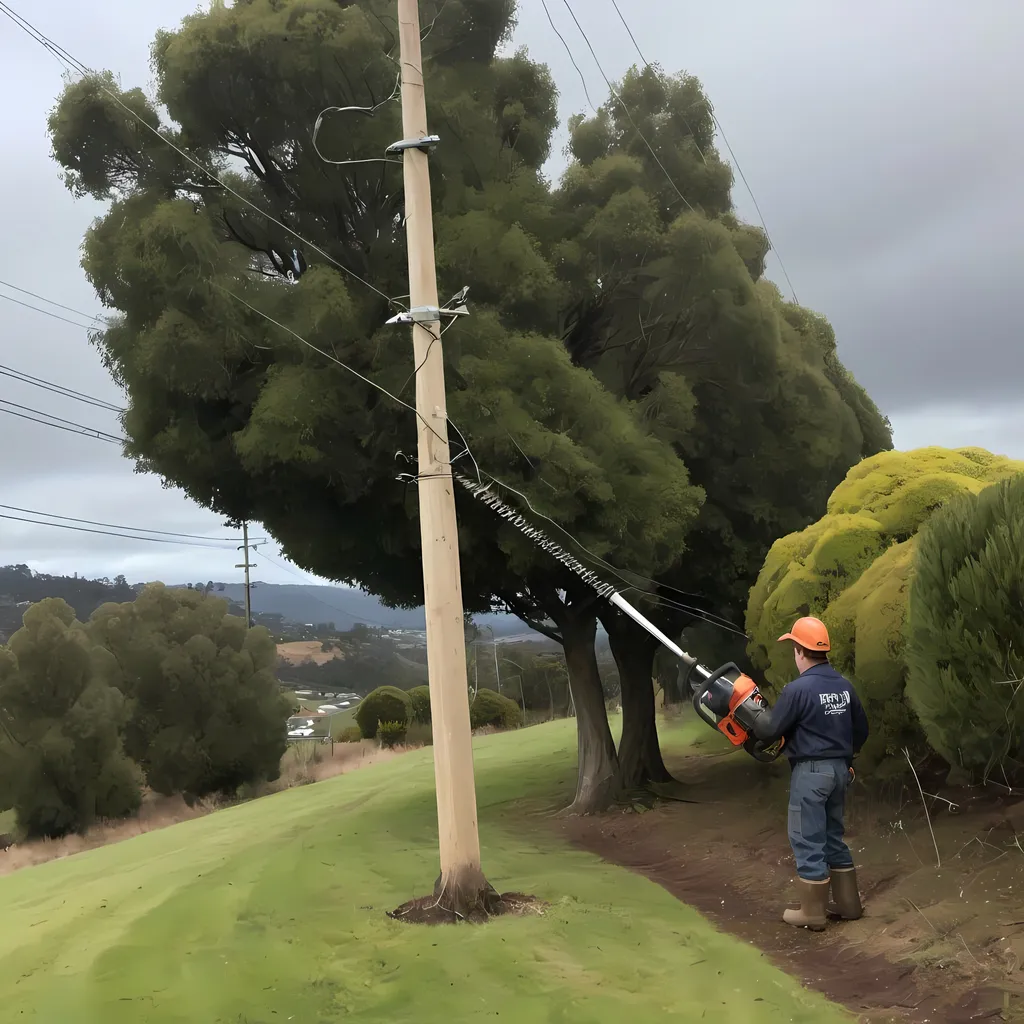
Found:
559,756 -> 1024,1024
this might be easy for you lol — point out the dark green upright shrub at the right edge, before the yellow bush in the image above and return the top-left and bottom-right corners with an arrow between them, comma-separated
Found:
907,474 -> 1024,782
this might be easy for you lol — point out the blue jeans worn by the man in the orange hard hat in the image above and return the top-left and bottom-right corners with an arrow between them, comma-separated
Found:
790,758 -> 853,882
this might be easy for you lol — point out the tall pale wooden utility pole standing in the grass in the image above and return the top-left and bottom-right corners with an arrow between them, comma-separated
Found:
398,0 -> 494,915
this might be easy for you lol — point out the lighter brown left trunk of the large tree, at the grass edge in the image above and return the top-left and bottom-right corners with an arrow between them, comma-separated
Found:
560,609 -> 617,814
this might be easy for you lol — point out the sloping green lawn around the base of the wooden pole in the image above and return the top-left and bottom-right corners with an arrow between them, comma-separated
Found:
0,722 -> 850,1024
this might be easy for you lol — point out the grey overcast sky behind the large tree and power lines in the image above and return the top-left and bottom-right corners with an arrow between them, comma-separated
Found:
0,0 -> 1024,583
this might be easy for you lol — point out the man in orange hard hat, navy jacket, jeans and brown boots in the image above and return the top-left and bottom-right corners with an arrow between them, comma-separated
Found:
741,617 -> 868,932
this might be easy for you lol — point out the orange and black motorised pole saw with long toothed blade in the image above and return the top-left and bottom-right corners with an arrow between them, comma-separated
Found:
454,473 -> 783,762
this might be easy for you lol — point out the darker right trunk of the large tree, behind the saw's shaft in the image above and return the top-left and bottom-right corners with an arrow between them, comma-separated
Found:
601,606 -> 675,792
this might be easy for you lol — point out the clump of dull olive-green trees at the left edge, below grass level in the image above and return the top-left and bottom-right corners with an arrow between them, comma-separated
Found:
0,584 -> 289,837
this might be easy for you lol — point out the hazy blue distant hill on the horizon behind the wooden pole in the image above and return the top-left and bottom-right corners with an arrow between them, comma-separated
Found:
208,583 -> 531,636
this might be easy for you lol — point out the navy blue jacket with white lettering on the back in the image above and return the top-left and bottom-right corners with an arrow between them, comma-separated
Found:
755,663 -> 868,764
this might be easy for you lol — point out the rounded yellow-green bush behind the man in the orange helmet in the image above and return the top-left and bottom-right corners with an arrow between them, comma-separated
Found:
746,447 -> 1024,765
